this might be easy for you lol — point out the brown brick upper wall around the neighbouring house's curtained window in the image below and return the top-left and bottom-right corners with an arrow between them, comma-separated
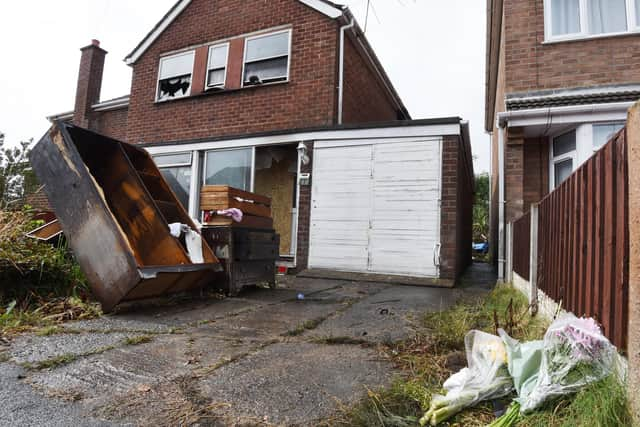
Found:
504,0 -> 640,93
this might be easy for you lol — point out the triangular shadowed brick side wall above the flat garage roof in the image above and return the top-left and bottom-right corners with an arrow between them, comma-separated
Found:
342,37 -> 398,123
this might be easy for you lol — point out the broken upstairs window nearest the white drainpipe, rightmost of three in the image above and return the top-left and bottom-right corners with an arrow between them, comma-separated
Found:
242,30 -> 291,86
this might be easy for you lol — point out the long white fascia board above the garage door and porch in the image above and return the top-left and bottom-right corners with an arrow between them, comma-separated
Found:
144,123 -> 461,154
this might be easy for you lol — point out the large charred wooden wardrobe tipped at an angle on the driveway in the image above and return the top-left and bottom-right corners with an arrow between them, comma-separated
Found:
31,122 -> 221,311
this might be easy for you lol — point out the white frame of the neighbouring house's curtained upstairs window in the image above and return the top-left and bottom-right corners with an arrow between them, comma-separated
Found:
544,0 -> 640,42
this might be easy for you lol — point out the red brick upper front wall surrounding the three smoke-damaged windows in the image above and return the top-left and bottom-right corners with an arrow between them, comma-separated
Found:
127,0 -> 338,143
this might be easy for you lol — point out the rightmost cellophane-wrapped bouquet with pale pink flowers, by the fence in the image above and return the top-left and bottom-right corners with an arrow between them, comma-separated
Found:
516,314 -> 619,414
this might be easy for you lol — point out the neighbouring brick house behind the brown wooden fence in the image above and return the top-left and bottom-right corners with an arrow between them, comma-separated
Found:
485,0 -> 640,278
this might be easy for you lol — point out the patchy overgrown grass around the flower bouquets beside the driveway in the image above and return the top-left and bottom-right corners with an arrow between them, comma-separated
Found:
321,285 -> 631,427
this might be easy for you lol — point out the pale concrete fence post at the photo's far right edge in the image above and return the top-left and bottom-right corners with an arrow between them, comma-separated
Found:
626,103 -> 640,425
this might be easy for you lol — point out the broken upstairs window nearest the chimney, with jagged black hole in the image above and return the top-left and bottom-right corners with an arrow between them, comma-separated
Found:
157,51 -> 195,101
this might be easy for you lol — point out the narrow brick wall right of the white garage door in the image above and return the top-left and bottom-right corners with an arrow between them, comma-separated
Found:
440,136 -> 474,280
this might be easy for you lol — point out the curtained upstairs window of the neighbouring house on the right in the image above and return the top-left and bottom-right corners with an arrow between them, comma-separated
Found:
545,0 -> 640,40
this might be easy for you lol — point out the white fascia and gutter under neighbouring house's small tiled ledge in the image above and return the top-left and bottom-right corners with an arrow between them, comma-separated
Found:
498,102 -> 634,127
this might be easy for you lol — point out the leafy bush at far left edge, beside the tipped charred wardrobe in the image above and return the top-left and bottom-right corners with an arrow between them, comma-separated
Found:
0,132 -> 38,209
